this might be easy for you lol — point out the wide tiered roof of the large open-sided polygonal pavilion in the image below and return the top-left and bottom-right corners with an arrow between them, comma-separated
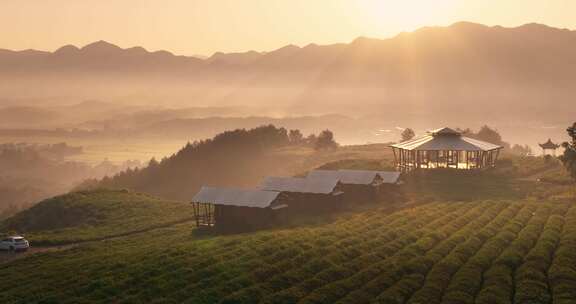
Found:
391,128 -> 502,151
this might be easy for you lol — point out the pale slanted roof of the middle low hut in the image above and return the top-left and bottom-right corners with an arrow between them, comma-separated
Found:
260,176 -> 339,194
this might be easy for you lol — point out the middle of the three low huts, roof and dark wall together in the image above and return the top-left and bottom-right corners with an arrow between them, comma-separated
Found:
260,176 -> 343,212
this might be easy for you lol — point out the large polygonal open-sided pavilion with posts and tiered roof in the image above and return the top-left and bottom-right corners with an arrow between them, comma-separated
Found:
391,128 -> 502,172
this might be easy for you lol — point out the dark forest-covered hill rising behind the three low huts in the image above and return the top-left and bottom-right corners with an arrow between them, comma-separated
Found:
79,125 -> 352,201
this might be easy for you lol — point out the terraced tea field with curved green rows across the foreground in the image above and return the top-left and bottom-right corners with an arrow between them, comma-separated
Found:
0,201 -> 576,304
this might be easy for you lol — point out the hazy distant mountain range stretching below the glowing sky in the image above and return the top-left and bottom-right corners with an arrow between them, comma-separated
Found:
0,22 -> 576,121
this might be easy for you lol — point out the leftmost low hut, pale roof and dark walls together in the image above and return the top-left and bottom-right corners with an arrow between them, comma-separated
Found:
192,187 -> 287,230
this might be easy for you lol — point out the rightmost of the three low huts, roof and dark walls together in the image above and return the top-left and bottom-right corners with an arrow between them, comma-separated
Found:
308,169 -> 400,202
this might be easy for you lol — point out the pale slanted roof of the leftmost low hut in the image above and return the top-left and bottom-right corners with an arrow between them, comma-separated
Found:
192,187 -> 279,208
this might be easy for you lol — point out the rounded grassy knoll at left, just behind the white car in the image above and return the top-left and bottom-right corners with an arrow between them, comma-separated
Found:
2,190 -> 192,245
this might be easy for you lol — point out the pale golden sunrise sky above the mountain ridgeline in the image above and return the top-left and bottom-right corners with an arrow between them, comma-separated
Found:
0,0 -> 576,55
